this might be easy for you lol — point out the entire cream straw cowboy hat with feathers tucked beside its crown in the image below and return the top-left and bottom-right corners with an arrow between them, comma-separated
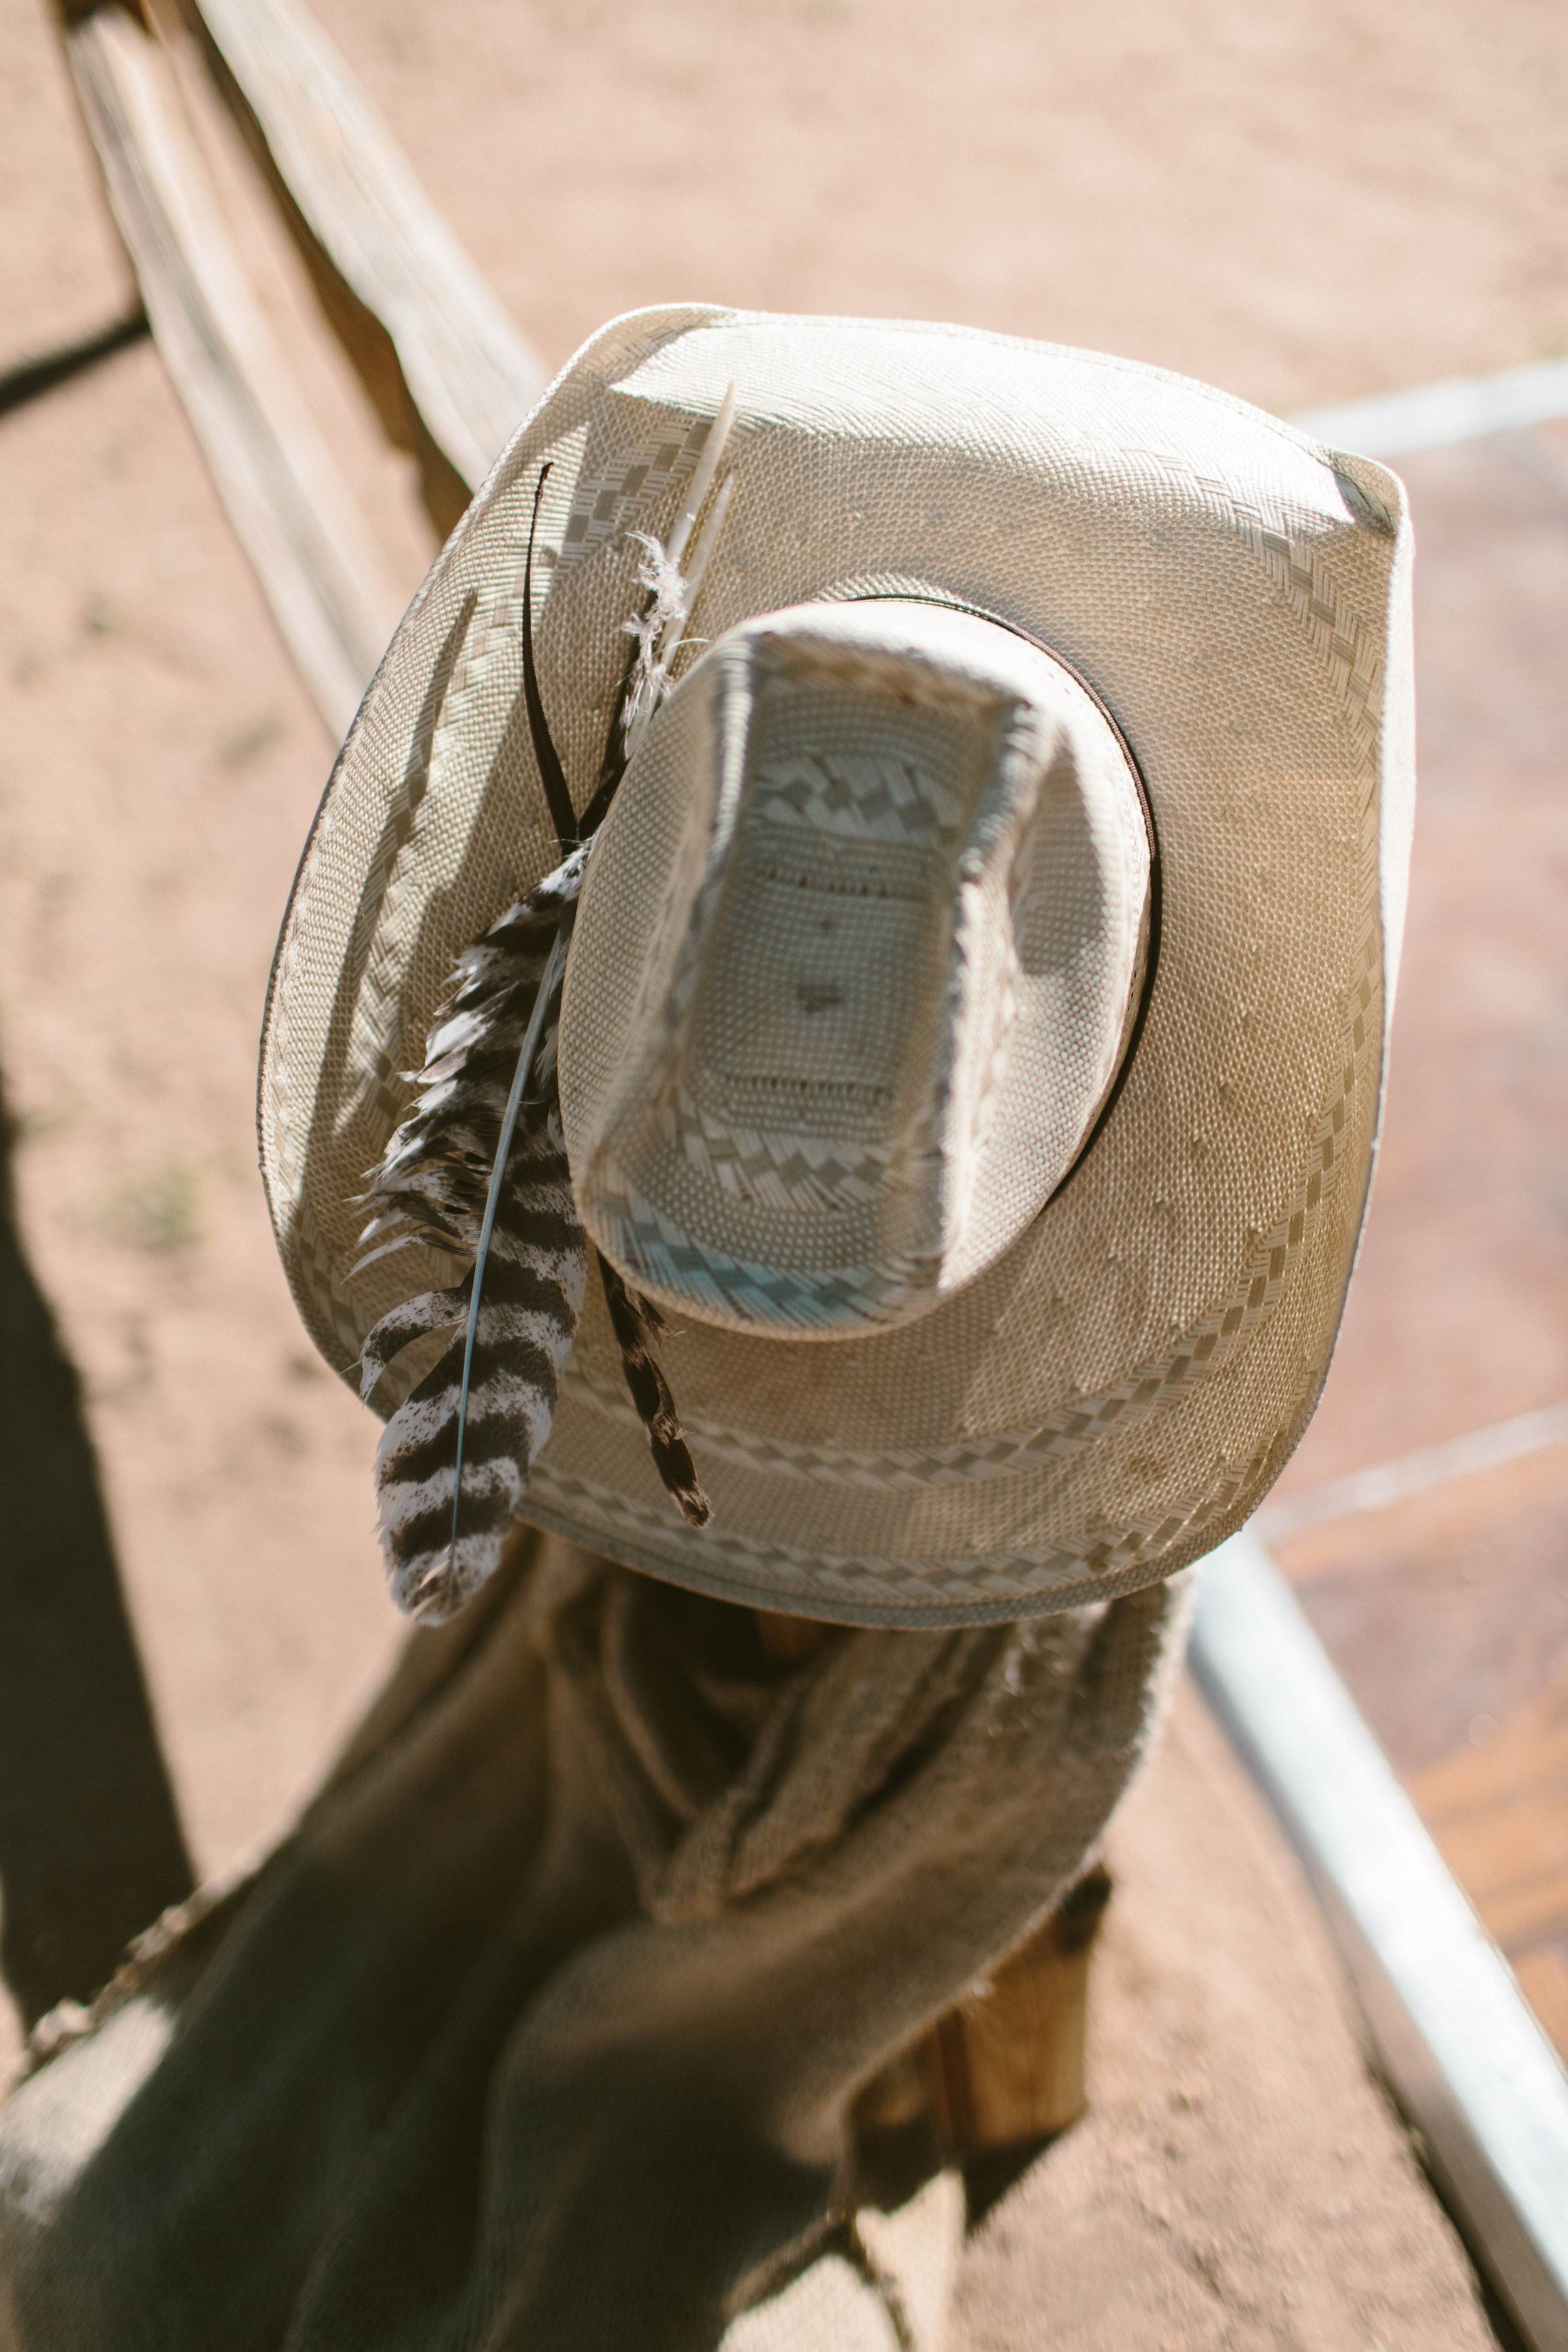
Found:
261,308 -> 1413,1625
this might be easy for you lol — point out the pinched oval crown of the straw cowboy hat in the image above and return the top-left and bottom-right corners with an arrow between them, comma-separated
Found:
562,598 -> 1150,1338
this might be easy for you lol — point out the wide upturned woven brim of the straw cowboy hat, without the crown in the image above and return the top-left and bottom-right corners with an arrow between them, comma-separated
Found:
261,308 -> 1413,1625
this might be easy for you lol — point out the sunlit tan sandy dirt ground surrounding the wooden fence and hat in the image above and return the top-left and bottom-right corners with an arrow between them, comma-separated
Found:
0,0 -> 1568,2352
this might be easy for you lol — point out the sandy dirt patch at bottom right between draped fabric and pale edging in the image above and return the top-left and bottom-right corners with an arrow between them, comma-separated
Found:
950,1691 -> 1490,2352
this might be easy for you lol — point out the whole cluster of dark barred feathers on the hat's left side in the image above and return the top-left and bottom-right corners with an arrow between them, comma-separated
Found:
359,442 -> 736,1623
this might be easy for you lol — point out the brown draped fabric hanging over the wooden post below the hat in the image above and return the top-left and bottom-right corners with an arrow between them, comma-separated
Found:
0,1536 -> 1185,2352
